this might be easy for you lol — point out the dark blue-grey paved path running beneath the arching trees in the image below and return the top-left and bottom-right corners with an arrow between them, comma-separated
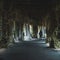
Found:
0,41 -> 60,60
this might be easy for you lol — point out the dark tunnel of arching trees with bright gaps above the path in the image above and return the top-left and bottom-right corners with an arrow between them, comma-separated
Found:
0,0 -> 60,47
